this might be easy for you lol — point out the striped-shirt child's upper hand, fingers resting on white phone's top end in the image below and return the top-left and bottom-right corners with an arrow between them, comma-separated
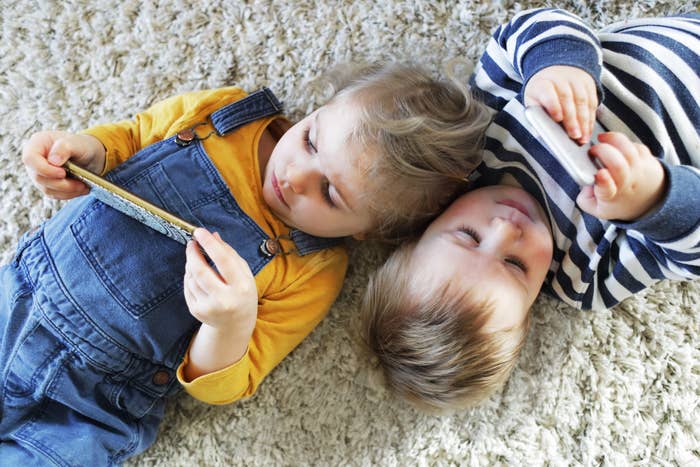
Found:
523,65 -> 598,144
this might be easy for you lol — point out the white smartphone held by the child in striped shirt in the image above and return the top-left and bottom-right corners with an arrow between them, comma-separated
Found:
525,106 -> 598,186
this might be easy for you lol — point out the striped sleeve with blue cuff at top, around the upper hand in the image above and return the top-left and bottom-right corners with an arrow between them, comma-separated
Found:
470,9 -> 602,111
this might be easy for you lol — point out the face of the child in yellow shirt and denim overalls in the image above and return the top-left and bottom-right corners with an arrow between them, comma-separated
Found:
263,101 -> 372,237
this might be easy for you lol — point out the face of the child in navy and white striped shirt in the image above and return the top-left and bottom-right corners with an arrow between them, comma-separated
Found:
413,185 -> 552,330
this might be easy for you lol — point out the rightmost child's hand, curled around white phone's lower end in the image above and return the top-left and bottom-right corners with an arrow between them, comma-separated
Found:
576,132 -> 666,221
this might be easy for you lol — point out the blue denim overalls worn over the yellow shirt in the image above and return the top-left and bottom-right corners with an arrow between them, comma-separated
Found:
0,89 -> 337,466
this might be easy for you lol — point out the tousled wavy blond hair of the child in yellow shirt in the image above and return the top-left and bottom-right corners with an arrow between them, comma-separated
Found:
324,63 -> 491,243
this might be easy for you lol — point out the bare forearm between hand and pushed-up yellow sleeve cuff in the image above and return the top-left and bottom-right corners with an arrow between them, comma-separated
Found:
183,322 -> 255,381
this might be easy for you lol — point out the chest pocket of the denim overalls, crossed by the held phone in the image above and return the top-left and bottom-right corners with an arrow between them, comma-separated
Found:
71,164 -> 192,318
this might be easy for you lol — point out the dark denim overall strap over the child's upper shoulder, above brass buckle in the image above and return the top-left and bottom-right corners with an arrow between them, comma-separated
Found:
211,87 -> 282,136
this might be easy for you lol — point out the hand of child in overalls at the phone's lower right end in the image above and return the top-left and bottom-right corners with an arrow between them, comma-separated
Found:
184,228 -> 258,332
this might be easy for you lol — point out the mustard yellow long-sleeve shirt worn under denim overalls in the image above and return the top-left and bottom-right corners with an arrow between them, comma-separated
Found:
84,87 -> 347,404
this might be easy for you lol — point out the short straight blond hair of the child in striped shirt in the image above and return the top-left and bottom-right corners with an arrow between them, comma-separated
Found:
361,243 -> 530,412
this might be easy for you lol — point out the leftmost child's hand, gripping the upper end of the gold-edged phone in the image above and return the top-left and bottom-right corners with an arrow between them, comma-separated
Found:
22,131 -> 105,199
